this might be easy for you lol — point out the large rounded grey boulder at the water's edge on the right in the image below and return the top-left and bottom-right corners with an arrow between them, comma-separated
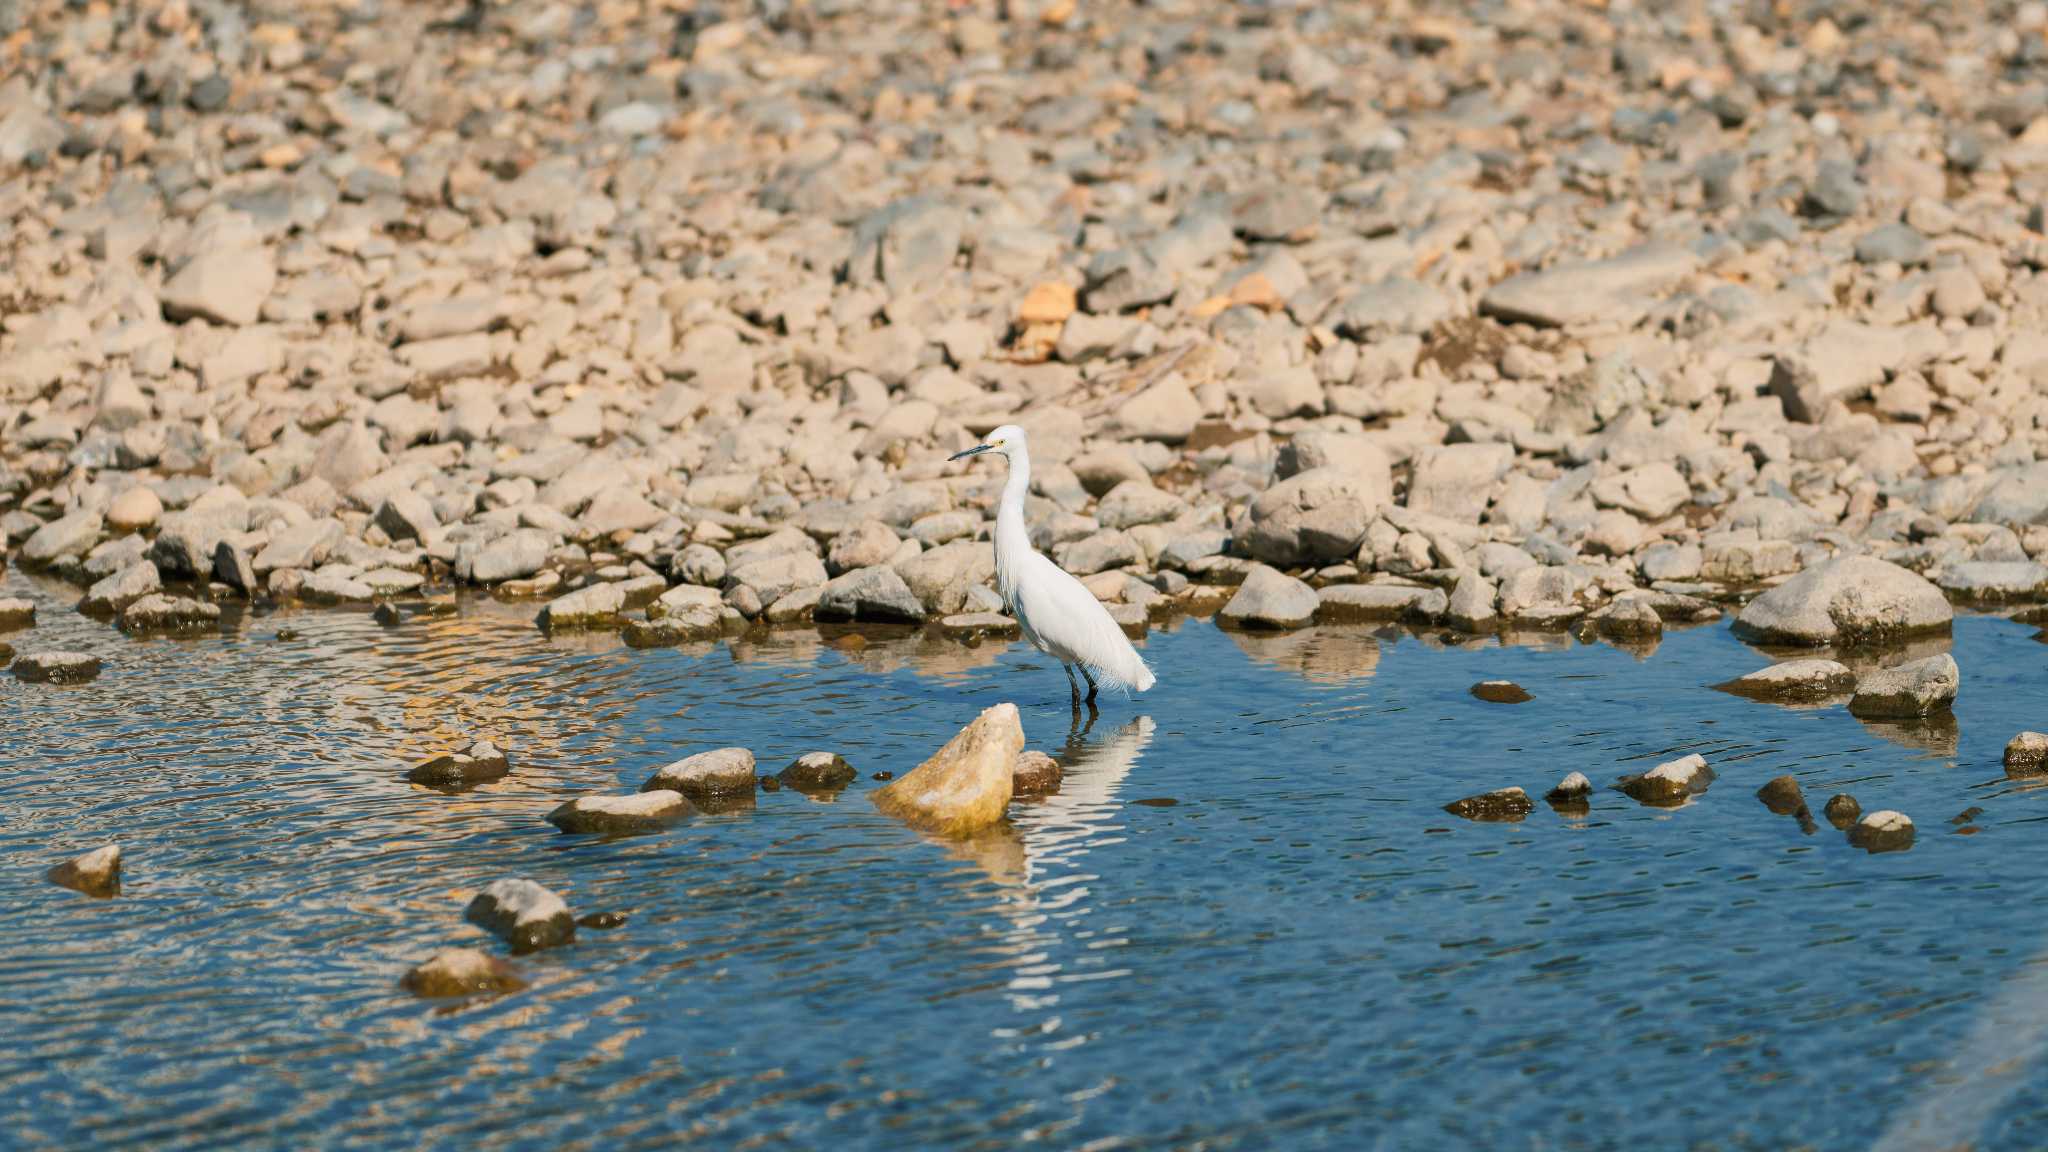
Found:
1735,556 -> 1954,646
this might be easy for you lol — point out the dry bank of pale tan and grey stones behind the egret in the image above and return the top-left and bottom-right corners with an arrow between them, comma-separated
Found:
0,0 -> 2048,644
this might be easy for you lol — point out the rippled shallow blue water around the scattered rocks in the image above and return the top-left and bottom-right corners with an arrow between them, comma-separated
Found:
0,574 -> 2048,1150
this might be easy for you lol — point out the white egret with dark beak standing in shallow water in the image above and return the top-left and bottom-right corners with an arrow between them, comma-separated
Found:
952,424 -> 1153,709
